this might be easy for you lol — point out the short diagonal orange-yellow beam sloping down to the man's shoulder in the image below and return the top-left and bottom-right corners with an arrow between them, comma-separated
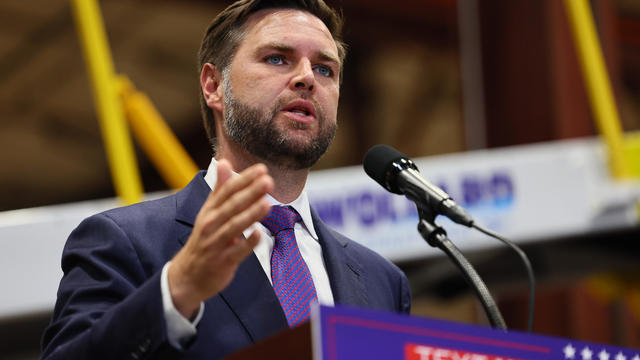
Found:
118,76 -> 198,189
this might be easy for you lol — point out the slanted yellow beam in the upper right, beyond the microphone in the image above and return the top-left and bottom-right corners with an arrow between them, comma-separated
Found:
564,0 -> 631,178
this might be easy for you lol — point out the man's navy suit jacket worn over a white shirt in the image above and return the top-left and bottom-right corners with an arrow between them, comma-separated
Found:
42,172 -> 410,360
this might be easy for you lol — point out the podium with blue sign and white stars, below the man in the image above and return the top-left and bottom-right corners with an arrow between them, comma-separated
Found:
228,306 -> 640,360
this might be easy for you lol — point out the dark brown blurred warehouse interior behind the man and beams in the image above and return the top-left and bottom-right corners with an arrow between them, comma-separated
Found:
0,0 -> 640,359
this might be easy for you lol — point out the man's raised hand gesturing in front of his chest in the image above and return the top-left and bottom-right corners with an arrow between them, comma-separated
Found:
168,160 -> 274,318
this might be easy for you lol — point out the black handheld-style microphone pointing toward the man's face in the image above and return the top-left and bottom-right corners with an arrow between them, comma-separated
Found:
363,145 -> 473,227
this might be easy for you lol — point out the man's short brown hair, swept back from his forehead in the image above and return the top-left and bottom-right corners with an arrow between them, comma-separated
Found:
198,0 -> 346,147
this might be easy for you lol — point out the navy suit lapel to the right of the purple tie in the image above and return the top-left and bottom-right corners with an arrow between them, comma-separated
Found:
311,208 -> 368,306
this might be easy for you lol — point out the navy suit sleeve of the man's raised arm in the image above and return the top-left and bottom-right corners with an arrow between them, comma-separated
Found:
42,214 -> 178,360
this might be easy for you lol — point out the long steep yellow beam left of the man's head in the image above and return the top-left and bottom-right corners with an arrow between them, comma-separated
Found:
71,0 -> 142,204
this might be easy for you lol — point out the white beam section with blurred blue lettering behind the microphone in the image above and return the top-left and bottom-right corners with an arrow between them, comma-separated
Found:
307,139 -> 640,261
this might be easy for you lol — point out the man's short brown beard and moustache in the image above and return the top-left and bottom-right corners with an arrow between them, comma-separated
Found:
223,74 -> 337,170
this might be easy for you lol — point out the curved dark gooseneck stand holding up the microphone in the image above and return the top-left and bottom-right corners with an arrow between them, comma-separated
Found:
418,207 -> 507,330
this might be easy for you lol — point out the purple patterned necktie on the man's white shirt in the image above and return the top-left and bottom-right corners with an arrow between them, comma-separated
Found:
261,206 -> 318,327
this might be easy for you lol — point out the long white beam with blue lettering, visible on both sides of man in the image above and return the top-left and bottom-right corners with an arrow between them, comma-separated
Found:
0,138 -> 640,318
